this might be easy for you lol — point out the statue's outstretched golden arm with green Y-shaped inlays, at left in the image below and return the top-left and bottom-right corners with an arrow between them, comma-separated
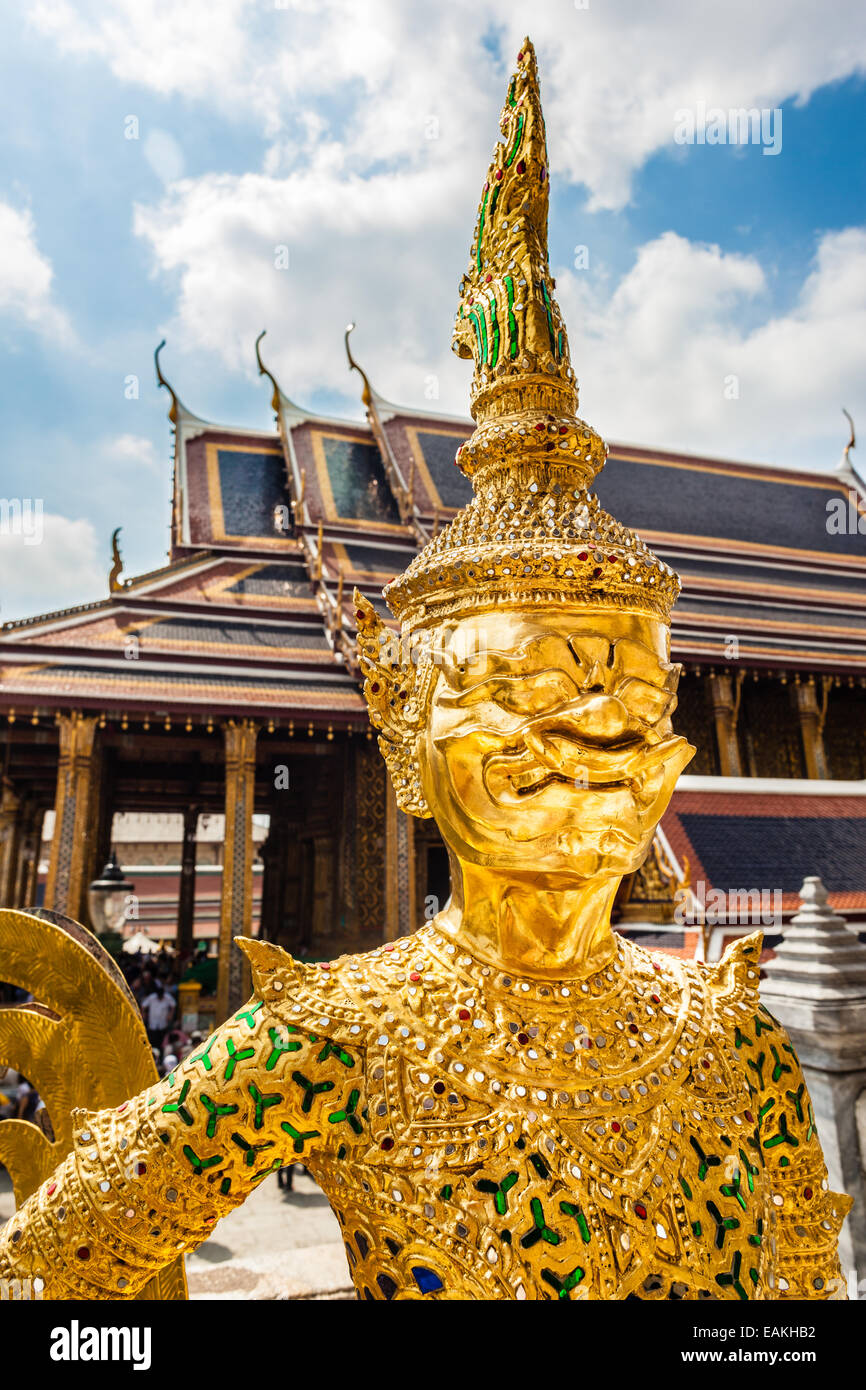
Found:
0,998 -> 366,1298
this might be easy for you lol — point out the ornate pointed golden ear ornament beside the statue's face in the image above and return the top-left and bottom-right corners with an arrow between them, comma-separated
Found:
353,589 -> 431,816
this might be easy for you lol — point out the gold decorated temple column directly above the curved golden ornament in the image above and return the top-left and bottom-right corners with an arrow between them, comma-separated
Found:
44,710 -> 99,922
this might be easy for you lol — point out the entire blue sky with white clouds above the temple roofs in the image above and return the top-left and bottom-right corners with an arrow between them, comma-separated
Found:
0,0 -> 866,619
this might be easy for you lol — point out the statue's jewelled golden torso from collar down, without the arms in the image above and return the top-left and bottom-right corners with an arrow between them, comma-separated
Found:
271,930 -> 773,1300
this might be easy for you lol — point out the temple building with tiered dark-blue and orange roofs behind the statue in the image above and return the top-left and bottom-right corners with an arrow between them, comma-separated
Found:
0,325 -> 866,1016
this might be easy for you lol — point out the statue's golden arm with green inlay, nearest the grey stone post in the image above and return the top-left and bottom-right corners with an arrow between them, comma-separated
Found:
741,1005 -> 851,1298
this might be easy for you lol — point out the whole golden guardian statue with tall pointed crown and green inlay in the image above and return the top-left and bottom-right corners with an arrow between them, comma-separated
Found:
0,40 -> 848,1301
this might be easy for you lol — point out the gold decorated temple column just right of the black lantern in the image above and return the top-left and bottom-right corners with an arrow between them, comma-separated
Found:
217,719 -> 259,1023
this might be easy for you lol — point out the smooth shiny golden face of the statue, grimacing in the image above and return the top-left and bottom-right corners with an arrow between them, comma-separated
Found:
418,609 -> 694,880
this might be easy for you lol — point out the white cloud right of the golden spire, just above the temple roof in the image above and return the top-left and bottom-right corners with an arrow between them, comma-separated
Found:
557,228 -> 866,468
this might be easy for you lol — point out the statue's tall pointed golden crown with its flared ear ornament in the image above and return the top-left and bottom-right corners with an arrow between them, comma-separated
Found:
356,39 -> 680,815
